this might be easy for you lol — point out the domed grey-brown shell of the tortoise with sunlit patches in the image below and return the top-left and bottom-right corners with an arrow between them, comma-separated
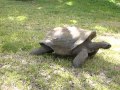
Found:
40,26 -> 96,55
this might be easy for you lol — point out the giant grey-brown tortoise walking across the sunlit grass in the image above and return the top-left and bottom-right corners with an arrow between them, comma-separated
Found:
30,26 -> 111,67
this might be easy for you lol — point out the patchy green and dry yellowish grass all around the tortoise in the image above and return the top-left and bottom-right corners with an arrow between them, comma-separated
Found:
0,0 -> 120,90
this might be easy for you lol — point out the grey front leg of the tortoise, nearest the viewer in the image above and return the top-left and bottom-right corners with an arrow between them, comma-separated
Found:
73,48 -> 88,68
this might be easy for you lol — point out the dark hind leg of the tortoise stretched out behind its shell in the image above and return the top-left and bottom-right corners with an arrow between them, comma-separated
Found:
30,46 -> 53,55
